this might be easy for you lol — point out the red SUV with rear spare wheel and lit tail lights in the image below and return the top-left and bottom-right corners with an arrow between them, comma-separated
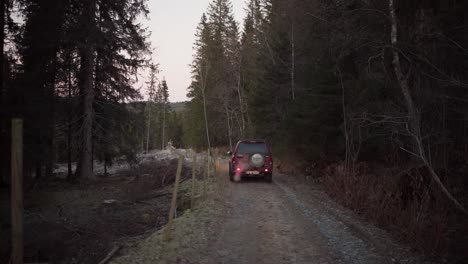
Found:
228,139 -> 273,182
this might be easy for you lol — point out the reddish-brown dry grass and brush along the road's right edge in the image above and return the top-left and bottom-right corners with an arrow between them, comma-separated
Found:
322,163 -> 466,256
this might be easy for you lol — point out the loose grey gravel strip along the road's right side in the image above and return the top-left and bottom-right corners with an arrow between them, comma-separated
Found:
275,174 -> 435,264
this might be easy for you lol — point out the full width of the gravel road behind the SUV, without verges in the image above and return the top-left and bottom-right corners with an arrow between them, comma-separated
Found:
213,169 -> 429,264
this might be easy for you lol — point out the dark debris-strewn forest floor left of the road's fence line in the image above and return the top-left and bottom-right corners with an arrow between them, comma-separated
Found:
0,153 -> 196,263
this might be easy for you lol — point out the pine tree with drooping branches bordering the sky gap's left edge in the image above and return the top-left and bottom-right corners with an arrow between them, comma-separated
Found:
78,0 -> 148,177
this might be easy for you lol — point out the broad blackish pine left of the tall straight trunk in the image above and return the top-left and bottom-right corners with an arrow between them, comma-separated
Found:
17,0 -> 69,178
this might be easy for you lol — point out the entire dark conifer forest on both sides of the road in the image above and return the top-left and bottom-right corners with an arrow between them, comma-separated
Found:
0,0 -> 468,262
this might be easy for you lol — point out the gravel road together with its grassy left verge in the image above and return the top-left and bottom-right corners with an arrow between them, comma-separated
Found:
111,161 -> 440,264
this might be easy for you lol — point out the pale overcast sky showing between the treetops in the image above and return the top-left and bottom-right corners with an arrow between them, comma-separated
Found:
142,0 -> 246,102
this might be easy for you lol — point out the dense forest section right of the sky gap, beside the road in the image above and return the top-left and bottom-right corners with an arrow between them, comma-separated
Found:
183,0 -> 468,254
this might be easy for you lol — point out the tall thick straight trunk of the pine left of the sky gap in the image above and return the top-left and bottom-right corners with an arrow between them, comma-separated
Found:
79,0 -> 96,178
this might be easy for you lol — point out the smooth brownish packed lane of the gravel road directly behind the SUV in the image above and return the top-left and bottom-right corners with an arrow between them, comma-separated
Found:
212,180 -> 339,264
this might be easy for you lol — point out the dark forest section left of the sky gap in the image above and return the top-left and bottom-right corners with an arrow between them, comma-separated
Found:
0,0 -> 186,181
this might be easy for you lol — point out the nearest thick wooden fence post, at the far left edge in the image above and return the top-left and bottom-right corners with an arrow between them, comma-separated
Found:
11,118 -> 23,264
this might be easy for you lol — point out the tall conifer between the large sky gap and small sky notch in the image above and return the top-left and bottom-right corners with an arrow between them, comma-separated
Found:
207,0 -> 245,142
